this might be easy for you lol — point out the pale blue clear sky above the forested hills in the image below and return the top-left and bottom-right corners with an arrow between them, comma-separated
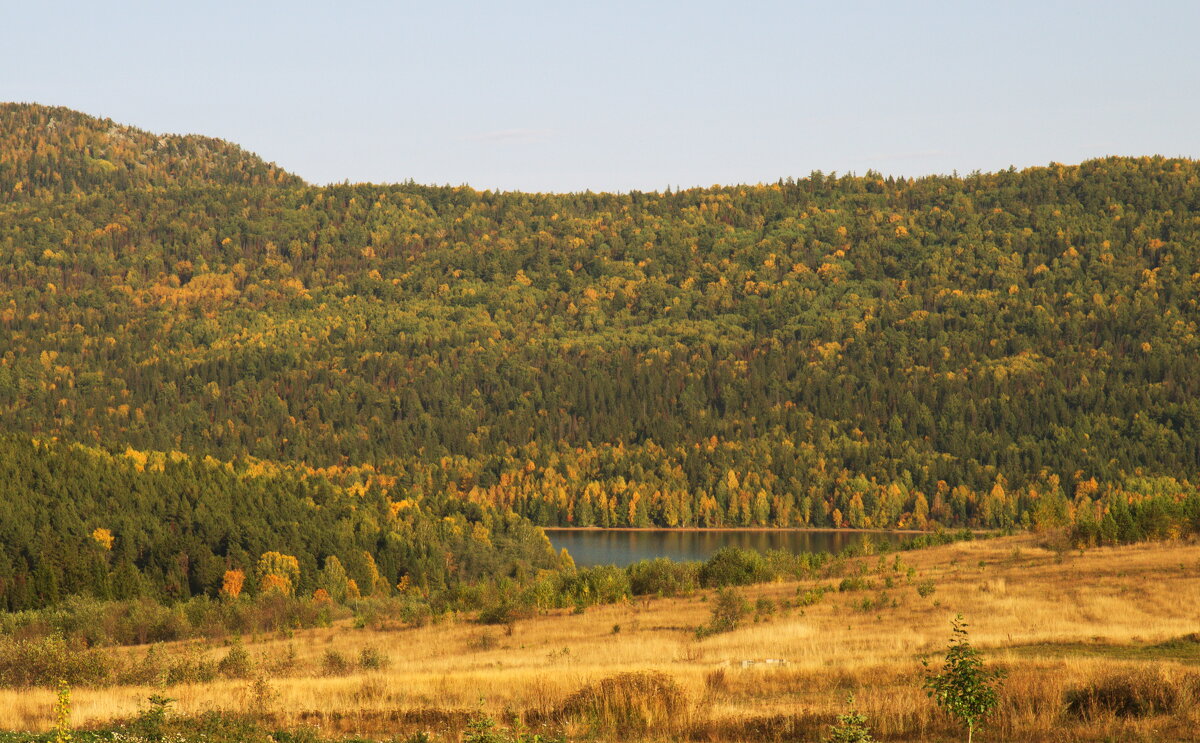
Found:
0,0 -> 1200,191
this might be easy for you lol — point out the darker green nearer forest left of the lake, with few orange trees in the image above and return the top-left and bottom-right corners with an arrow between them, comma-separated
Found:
0,437 -> 559,611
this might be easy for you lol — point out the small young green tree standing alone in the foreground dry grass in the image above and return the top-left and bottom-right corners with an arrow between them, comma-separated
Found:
922,615 -> 1004,743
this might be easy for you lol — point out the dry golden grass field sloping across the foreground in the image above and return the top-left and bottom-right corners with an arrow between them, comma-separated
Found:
0,535 -> 1200,742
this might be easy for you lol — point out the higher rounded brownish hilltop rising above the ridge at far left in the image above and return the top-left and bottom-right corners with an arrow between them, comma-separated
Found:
0,103 -> 304,198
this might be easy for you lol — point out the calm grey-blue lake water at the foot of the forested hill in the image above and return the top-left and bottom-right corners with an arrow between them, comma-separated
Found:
546,529 -> 908,567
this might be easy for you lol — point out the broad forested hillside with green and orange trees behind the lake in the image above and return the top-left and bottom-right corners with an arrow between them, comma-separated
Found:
0,107 -> 1200,535
